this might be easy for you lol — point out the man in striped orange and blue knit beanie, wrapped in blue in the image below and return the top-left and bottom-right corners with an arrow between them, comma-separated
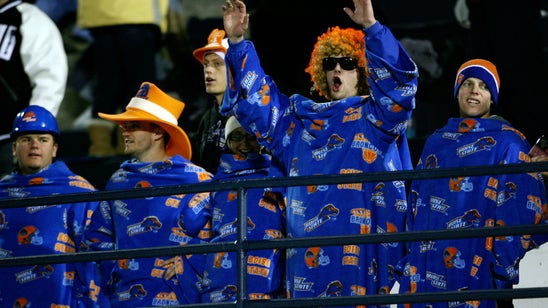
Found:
398,59 -> 547,307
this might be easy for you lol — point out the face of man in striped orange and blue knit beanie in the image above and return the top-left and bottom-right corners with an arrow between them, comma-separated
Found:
457,77 -> 493,118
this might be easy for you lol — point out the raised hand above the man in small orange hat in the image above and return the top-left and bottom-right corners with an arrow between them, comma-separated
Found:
222,0 -> 249,44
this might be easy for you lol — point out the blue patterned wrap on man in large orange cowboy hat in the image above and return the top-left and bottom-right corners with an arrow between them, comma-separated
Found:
86,155 -> 211,307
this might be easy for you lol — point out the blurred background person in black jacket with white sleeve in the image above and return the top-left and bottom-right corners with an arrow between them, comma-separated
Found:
0,0 -> 68,174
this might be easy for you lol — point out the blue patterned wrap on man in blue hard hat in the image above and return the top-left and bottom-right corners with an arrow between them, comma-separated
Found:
0,161 -> 102,307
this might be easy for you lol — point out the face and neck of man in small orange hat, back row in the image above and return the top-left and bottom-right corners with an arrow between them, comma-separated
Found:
204,52 -> 226,105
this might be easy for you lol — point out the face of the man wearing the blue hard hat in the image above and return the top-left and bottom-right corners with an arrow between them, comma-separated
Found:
12,134 -> 58,175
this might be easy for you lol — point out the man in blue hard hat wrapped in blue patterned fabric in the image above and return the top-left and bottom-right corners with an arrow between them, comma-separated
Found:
0,105 -> 105,307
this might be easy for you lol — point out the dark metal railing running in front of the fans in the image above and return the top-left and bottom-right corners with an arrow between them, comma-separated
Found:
0,162 -> 548,307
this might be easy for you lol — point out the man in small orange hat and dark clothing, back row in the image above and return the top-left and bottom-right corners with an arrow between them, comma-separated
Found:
191,29 -> 228,173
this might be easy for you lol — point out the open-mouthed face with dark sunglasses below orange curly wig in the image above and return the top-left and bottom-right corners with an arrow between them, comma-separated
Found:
324,55 -> 358,100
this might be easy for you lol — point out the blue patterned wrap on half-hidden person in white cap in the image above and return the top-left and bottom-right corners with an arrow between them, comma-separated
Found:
202,153 -> 285,303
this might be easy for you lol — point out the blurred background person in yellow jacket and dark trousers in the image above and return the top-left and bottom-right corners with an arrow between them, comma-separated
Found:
77,0 -> 169,157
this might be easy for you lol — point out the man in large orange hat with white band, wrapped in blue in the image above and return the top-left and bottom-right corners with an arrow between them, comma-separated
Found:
86,82 -> 211,307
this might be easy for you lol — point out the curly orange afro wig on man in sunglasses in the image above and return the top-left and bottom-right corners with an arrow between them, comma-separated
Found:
304,26 -> 369,99
